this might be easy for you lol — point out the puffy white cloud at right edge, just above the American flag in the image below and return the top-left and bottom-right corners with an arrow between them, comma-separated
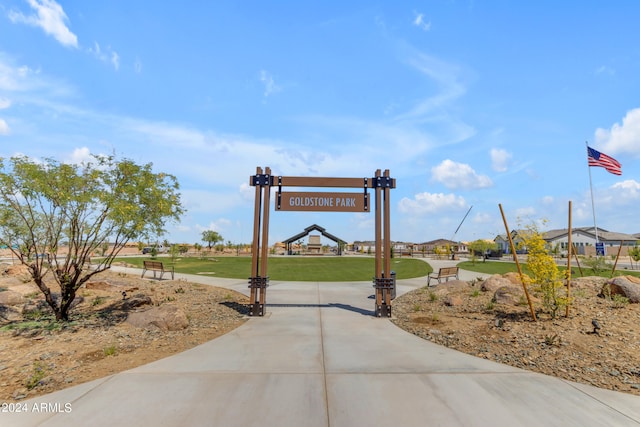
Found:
595,108 -> 640,157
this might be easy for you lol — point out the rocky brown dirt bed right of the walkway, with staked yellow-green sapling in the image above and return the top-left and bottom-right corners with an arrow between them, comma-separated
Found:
393,277 -> 640,396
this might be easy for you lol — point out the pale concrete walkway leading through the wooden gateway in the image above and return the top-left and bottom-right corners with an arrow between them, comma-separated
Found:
5,260 -> 640,427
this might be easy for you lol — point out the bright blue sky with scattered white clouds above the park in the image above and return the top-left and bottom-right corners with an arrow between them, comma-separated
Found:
0,0 -> 640,243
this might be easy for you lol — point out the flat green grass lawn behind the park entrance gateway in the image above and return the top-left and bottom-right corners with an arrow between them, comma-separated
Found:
115,256 -> 433,282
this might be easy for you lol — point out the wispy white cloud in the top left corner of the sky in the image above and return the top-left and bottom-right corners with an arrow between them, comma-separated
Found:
9,0 -> 78,48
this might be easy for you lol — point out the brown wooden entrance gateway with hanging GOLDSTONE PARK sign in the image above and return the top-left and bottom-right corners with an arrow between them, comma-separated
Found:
249,167 -> 396,317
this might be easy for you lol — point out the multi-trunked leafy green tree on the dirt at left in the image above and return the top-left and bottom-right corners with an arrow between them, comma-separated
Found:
0,156 -> 183,321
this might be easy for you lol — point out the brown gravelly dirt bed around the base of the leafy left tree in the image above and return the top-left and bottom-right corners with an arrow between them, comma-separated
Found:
0,266 -> 247,402
